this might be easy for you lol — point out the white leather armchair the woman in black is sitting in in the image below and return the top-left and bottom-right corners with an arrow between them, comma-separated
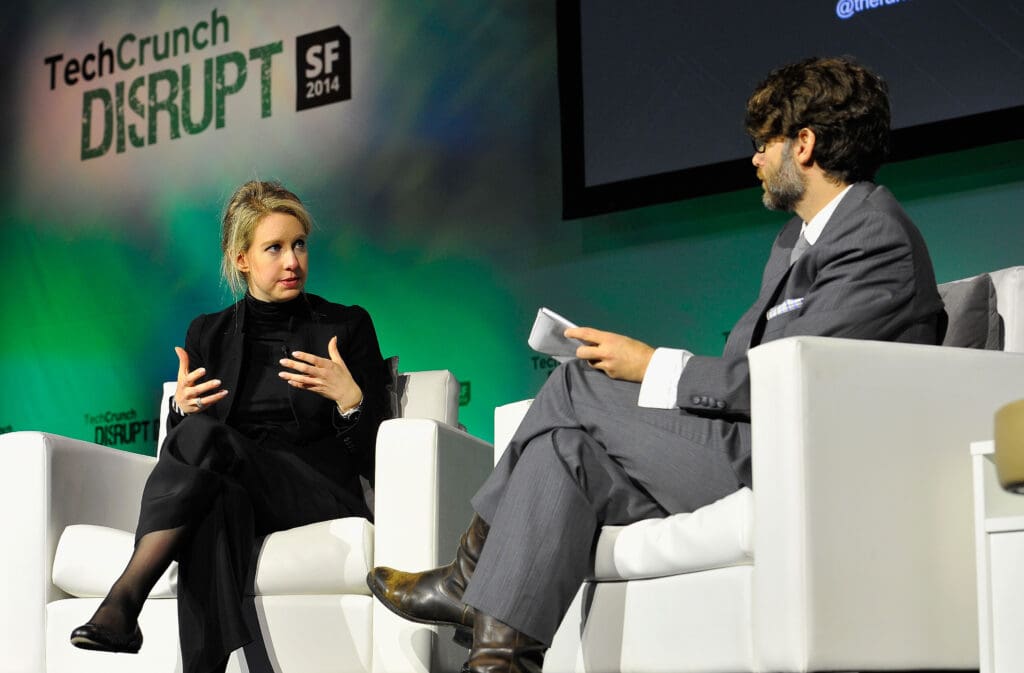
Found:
0,371 -> 492,673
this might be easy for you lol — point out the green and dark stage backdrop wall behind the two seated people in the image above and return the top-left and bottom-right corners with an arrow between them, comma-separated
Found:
0,0 -> 1024,454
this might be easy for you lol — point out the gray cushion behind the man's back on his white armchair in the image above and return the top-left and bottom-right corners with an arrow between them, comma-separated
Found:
938,274 -> 1004,350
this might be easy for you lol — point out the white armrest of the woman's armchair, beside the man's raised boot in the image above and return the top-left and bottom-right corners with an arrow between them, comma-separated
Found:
373,418 -> 494,673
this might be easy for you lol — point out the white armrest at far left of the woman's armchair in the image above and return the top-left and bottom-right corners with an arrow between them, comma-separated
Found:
0,432 -> 156,672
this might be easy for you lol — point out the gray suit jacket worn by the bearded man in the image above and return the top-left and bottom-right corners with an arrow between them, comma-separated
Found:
677,182 -> 944,485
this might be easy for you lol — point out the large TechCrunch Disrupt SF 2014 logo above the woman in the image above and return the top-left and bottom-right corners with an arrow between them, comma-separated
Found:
43,9 -> 351,161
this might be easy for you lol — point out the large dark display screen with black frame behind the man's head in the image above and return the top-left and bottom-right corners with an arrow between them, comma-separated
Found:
558,0 -> 1024,216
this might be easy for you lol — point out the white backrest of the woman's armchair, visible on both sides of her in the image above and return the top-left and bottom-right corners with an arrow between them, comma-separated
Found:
157,370 -> 459,451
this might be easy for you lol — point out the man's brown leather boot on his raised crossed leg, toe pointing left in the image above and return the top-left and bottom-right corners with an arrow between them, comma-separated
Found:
367,514 -> 490,647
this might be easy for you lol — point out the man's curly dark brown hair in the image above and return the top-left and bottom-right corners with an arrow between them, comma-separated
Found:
745,57 -> 890,183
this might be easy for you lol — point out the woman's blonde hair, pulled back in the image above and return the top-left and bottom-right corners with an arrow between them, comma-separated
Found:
220,180 -> 312,295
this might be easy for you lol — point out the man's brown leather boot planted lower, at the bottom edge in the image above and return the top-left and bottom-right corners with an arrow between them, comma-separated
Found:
462,612 -> 548,673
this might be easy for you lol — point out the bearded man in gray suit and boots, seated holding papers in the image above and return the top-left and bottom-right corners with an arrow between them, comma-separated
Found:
368,58 -> 944,673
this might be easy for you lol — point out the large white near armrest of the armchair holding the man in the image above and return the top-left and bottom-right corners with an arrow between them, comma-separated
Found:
750,337 -> 1024,670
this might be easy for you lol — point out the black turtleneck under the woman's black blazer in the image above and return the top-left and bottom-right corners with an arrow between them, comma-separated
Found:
231,292 -> 306,438
